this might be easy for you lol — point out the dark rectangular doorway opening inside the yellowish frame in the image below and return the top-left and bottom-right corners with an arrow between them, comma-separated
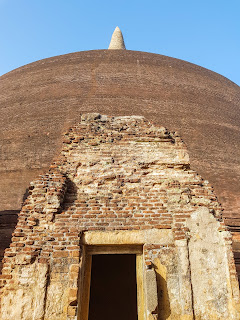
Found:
89,254 -> 137,320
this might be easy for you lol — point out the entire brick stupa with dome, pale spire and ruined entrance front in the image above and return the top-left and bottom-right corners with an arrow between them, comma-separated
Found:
0,28 -> 240,320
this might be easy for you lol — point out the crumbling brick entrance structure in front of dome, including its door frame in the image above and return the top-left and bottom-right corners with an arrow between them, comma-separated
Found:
1,113 -> 239,320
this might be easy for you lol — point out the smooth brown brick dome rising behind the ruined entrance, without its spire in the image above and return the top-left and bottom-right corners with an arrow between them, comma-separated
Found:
0,50 -> 240,217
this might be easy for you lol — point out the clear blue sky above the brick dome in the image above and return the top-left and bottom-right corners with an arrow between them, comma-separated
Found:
0,0 -> 240,85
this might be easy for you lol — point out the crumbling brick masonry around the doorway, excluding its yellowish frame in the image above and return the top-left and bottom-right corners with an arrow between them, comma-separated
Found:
1,114 -> 238,320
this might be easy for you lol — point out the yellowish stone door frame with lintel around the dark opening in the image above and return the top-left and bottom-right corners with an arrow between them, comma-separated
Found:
77,231 -> 145,320
